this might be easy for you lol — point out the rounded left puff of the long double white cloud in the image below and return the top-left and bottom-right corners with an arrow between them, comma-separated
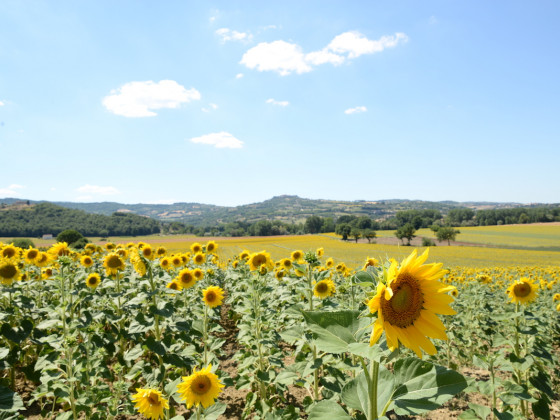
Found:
241,41 -> 312,76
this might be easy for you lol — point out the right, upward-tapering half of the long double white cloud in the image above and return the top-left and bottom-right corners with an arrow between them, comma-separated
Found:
327,31 -> 408,58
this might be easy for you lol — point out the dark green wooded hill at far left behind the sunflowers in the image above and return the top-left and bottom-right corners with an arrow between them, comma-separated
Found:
0,203 -> 160,237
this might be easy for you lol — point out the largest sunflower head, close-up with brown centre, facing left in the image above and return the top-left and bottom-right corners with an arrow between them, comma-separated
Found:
368,250 -> 456,358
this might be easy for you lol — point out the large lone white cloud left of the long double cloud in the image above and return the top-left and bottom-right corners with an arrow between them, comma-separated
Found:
103,80 -> 200,117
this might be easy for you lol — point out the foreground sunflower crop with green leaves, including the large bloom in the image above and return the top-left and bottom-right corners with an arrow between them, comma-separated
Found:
0,241 -> 560,420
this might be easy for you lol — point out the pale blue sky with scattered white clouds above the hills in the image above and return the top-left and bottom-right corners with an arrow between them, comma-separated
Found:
0,0 -> 560,205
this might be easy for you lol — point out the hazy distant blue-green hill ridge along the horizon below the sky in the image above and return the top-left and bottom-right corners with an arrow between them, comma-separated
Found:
0,195 -> 546,226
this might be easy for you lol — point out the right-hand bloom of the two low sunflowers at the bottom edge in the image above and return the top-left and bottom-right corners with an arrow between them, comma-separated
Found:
177,365 -> 224,408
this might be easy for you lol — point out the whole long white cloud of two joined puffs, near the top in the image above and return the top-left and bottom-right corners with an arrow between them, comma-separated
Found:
240,31 -> 408,76
